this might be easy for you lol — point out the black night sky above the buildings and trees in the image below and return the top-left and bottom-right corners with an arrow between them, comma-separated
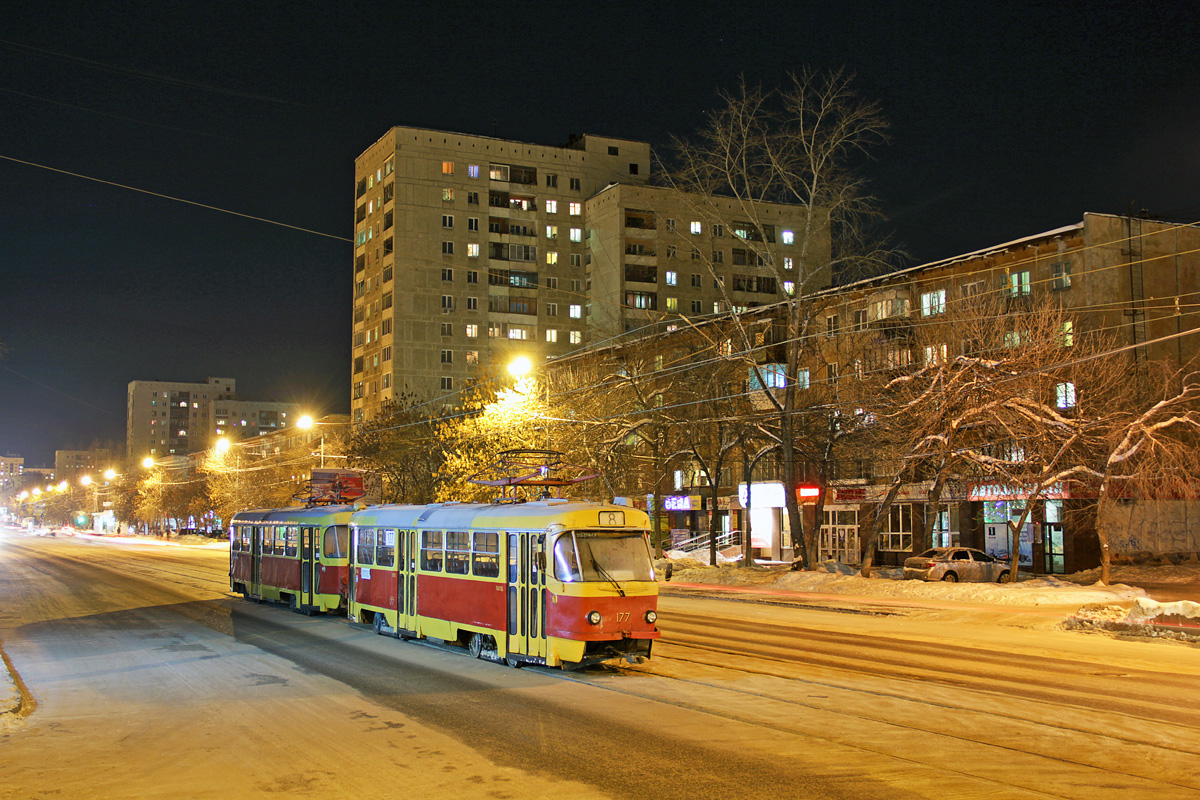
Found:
0,0 -> 1200,467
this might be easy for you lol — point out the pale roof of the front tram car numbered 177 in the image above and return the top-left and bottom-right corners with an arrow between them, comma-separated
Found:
350,499 -> 649,529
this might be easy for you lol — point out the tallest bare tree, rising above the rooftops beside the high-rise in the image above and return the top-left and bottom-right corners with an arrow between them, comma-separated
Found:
672,70 -> 888,569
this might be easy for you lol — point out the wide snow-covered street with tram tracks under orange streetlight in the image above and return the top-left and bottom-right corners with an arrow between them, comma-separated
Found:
0,529 -> 1200,800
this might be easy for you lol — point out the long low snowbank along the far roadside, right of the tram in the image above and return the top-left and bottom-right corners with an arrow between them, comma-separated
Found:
671,559 -> 1146,606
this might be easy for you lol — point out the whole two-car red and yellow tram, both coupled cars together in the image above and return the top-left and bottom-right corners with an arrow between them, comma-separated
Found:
230,499 -> 659,668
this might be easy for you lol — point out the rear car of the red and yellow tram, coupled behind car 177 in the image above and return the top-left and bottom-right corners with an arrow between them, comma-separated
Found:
229,505 -> 354,614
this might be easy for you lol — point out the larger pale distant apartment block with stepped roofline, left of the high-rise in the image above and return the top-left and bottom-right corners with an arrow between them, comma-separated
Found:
125,378 -> 300,459
